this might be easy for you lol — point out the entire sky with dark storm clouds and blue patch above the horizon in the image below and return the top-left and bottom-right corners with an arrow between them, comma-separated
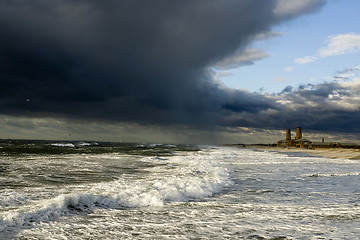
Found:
0,0 -> 360,144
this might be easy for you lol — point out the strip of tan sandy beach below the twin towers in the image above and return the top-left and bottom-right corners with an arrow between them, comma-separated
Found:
250,146 -> 360,160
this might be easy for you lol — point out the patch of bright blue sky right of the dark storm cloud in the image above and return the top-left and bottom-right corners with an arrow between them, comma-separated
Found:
218,0 -> 360,93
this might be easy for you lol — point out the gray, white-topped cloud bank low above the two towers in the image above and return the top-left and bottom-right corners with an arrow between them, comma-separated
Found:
229,82 -> 360,132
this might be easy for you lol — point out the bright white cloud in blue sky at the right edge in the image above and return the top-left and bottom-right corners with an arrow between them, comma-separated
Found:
318,33 -> 360,58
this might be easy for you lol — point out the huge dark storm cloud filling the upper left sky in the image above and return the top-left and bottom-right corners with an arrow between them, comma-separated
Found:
0,0 -> 324,129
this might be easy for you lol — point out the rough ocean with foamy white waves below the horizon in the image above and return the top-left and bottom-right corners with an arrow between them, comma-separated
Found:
0,141 -> 360,240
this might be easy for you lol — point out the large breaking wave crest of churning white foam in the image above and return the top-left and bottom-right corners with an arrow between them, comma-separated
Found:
0,147 -> 231,230
